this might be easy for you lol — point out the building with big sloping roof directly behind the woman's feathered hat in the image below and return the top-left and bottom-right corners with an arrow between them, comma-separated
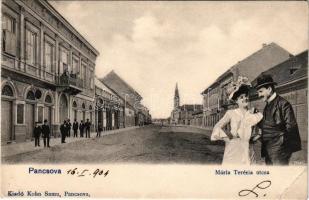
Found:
202,43 -> 291,129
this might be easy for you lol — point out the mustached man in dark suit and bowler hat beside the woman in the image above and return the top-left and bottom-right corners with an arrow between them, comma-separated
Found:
255,73 -> 301,165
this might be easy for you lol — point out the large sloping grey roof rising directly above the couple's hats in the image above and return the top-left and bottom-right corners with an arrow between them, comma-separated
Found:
202,42 -> 292,94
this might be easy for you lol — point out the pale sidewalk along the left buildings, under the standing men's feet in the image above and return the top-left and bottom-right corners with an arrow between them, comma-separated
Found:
1,126 -> 139,158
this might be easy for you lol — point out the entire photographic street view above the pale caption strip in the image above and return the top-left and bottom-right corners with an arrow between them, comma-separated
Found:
1,0 -> 308,165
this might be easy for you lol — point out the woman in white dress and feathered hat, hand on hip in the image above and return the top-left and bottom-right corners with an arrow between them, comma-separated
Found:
211,77 -> 263,165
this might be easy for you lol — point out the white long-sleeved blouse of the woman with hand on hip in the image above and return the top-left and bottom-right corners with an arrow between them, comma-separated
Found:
211,108 -> 263,141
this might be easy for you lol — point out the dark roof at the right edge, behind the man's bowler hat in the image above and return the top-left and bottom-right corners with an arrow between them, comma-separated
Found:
252,50 -> 308,86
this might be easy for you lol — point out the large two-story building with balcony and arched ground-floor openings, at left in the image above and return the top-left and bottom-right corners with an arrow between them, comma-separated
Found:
1,0 -> 99,143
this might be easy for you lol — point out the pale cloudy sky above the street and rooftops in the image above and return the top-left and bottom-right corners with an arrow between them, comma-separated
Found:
50,1 -> 308,118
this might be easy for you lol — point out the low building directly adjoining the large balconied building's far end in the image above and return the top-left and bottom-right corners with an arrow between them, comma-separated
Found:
95,78 -> 124,131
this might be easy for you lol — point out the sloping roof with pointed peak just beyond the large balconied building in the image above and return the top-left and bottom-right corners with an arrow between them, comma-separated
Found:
99,70 -> 142,106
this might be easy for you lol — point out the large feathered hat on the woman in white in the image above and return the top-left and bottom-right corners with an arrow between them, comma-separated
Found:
227,76 -> 251,100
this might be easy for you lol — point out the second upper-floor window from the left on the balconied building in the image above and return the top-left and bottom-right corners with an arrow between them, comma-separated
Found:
26,29 -> 37,65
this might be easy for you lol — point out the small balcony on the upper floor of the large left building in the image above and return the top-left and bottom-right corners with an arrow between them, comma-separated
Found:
56,73 -> 83,95
